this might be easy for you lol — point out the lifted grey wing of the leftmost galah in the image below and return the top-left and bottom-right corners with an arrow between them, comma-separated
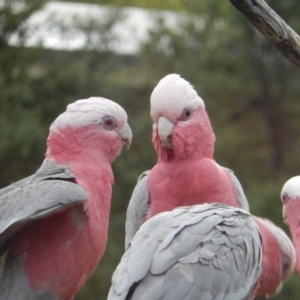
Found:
0,161 -> 87,247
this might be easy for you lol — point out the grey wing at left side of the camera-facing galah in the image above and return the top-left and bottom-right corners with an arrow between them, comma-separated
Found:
125,171 -> 150,249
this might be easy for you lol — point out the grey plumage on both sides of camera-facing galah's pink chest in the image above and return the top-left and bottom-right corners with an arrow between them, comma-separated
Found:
125,166 -> 249,249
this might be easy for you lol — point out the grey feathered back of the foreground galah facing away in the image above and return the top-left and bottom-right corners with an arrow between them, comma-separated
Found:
107,203 -> 262,300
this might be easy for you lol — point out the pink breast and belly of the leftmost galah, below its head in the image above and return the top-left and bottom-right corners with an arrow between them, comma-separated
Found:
0,166 -> 112,300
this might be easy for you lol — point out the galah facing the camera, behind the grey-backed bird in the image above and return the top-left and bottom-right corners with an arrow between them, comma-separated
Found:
125,74 -> 249,248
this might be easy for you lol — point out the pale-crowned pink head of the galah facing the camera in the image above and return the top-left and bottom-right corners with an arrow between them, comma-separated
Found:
150,74 -> 215,160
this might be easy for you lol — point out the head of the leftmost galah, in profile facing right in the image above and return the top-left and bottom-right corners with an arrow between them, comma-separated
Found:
46,97 -> 132,162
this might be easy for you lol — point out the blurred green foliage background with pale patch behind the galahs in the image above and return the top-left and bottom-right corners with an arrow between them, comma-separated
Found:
0,0 -> 300,300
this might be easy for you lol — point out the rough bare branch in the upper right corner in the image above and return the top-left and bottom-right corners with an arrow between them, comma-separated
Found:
230,0 -> 300,68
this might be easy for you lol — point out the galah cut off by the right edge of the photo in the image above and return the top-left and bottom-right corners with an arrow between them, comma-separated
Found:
281,176 -> 300,276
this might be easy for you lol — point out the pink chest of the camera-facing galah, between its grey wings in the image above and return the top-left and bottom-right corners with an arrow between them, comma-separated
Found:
148,161 -> 228,215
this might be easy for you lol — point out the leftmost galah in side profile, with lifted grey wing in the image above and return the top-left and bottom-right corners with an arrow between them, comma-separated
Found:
0,97 -> 132,300
